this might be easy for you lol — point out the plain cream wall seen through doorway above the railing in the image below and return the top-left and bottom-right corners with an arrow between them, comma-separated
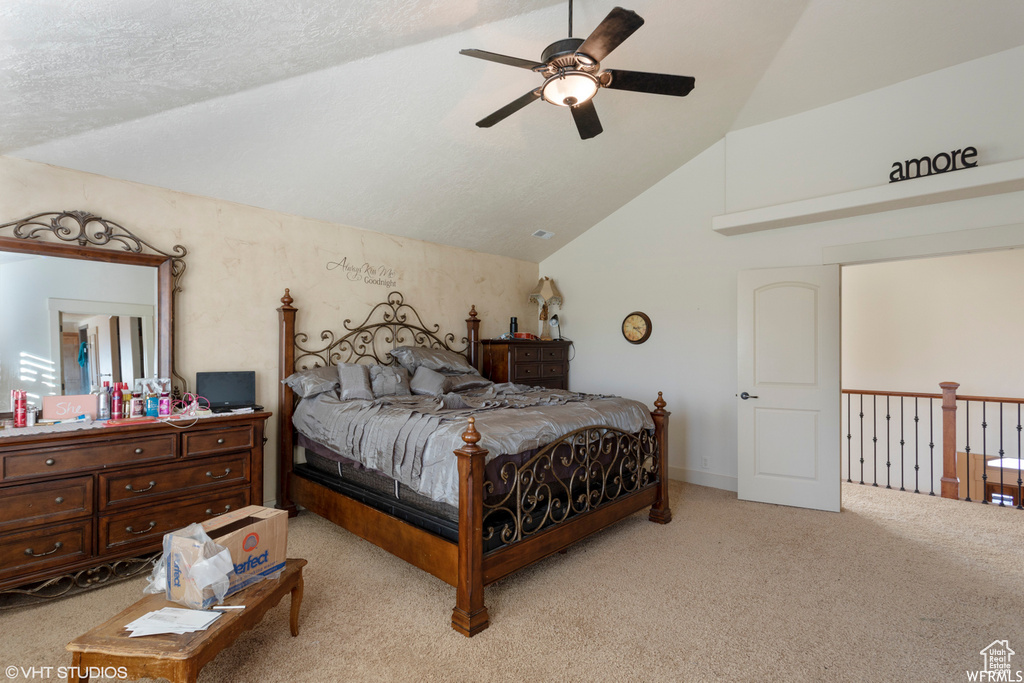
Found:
843,249 -> 1024,397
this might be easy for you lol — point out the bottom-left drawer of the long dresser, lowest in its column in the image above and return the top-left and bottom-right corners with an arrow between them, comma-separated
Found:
0,519 -> 92,580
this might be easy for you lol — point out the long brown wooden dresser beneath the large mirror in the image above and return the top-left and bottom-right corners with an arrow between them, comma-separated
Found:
0,413 -> 270,590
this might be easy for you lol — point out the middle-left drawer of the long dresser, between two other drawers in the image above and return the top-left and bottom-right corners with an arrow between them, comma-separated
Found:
0,477 -> 92,531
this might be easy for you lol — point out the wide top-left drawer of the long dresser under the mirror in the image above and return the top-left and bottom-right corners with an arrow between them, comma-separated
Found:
3,434 -> 174,479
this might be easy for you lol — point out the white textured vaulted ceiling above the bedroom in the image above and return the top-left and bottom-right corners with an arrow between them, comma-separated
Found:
0,0 -> 1024,261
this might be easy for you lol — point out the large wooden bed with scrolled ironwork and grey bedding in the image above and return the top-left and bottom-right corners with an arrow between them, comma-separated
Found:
278,290 -> 672,636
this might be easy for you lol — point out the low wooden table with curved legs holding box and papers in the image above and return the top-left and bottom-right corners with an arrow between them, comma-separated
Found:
68,559 -> 306,683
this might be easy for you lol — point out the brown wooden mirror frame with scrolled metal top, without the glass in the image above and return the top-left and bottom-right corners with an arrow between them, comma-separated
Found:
0,211 -> 188,394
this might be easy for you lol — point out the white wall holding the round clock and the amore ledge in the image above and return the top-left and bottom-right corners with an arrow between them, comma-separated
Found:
541,50 -> 1024,489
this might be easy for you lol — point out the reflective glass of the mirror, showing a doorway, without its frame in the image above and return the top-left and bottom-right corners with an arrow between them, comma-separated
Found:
0,252 -> 158,412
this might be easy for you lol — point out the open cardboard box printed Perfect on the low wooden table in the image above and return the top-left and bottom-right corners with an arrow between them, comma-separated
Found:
164,505 -> 288,609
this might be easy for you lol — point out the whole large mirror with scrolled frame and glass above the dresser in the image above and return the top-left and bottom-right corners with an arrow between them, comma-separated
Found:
0,211 -> 188,413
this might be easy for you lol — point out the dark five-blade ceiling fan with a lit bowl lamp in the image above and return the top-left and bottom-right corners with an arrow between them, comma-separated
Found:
459,0 -> 694,140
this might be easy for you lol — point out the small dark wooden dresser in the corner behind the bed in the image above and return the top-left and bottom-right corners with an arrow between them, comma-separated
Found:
480,339 -> 570,390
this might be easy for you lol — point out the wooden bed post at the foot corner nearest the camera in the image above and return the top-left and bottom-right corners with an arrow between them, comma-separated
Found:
452,418 -> 490,637
